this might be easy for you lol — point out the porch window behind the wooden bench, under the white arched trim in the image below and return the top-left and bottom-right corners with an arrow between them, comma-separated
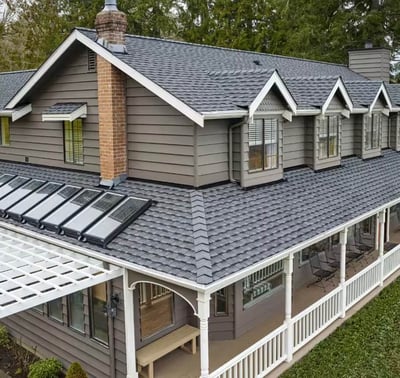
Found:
139,283 -> 174,339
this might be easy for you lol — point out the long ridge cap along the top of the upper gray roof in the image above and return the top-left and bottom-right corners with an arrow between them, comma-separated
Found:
75,27 -> 348,68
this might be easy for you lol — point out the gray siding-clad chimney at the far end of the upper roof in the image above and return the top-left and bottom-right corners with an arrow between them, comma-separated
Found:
349,42 -> 391,82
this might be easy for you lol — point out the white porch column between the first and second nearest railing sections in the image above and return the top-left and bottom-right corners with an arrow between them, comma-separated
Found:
284,253 -> 293,362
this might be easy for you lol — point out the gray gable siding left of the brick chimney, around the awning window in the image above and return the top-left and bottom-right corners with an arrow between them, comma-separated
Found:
0,46 -> 100,172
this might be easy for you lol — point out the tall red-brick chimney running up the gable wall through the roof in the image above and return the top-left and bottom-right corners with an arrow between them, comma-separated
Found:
96,0 -> 128,187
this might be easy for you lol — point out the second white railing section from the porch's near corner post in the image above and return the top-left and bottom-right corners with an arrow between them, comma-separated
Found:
292,287 -> 342,352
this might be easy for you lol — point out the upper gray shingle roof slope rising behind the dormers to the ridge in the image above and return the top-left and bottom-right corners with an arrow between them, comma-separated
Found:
78,28 -> 365,112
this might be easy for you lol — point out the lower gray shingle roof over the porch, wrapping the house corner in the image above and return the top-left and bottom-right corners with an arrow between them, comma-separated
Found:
0,150 -> 400,284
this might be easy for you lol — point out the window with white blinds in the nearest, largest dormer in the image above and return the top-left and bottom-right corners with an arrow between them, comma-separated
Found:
249,119 -> 278,171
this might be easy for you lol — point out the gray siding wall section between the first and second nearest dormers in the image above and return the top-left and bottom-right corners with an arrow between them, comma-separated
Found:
283,117 -> 306,168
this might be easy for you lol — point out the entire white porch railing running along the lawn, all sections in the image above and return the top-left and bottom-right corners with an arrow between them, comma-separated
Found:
209,245 -> 400,378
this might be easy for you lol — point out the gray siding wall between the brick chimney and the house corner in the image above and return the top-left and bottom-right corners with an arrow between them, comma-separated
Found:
127,78 -> 195,185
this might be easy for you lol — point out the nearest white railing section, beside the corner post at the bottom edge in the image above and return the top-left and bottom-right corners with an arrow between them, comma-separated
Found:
209,325 -> 287,378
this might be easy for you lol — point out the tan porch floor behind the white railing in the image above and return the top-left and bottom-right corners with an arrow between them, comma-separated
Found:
145,238 -> 400,378
